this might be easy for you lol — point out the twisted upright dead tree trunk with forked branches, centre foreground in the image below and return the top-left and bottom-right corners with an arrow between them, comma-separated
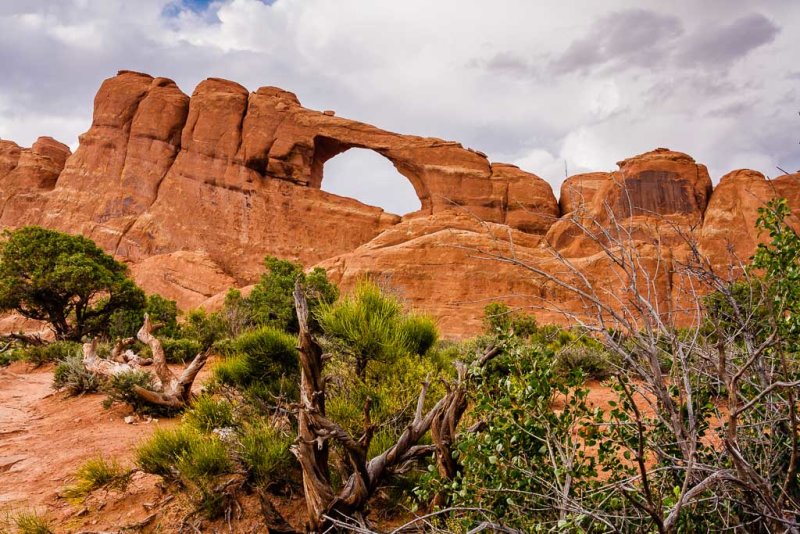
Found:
292,282 -> 485,532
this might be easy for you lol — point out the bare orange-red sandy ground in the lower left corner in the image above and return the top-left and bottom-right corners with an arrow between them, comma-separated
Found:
0,362 -> 304,534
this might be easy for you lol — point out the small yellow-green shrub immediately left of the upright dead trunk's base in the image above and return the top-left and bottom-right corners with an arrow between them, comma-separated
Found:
241,422 -> 292,486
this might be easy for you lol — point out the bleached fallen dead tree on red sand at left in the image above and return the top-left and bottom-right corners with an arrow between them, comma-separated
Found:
83,314 -> 210,409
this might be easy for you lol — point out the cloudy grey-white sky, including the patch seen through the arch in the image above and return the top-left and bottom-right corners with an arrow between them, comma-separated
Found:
0,0 -> 800,213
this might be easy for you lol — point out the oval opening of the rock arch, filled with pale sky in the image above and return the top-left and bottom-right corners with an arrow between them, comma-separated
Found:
320,147 -> 422,215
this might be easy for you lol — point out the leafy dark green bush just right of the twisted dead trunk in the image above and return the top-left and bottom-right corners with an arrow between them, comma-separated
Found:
417,340 -> 597,532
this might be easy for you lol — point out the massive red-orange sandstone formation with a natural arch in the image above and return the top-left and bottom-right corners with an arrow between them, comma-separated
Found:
0,71 -> 800,335
